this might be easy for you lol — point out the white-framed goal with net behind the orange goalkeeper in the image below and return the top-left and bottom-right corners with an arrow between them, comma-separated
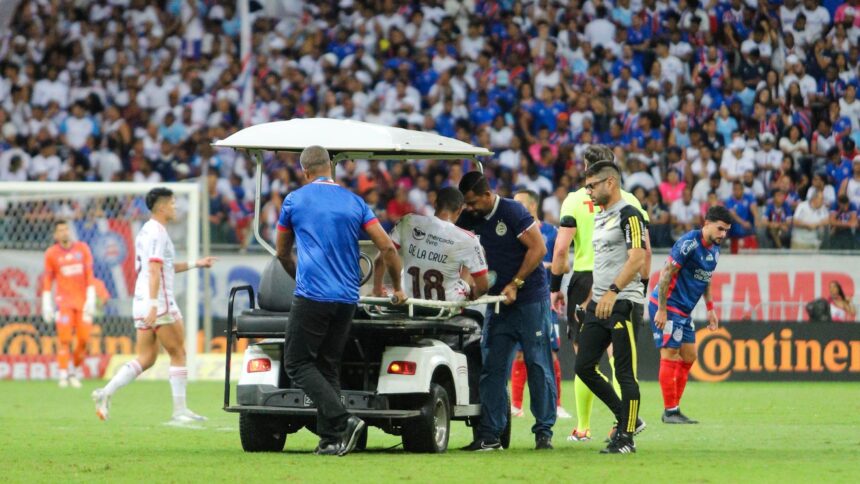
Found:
0,182 -> 200,377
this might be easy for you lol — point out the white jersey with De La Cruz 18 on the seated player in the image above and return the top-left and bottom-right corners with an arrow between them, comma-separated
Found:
391,214 -> 487,301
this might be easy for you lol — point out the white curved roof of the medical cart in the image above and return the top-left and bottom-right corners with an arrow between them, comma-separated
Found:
215,118 -> 493,159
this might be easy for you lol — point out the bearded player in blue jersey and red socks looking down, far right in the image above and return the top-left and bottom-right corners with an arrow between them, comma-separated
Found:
648,205 -> 733,424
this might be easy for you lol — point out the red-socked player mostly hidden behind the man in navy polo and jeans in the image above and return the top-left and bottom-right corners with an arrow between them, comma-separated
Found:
511,190 -> 571,418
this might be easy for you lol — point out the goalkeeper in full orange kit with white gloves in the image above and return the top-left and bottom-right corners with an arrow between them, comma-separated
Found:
42,221 -> 96,388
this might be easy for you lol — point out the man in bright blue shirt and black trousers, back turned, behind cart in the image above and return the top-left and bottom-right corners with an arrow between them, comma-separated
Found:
276,146 -> 406,455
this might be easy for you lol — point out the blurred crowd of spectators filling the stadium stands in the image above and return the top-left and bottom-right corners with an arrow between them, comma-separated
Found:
0,0 -> 860,250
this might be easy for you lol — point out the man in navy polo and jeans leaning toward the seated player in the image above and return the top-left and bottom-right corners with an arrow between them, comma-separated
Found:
458,171 -> 556,451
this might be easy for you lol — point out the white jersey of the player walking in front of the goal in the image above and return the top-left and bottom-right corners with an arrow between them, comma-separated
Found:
132,219 -> 178,319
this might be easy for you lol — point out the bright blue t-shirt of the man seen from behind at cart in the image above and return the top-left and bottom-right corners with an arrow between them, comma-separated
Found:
278,178 -> 379,304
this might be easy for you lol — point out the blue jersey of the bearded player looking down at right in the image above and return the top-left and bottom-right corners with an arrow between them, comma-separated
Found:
650,230 -> 720,317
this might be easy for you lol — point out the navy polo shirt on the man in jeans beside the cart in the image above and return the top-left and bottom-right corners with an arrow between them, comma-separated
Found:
466,196 -> 549,303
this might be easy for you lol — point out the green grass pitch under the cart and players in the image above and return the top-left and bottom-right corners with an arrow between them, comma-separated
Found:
0,381 -> 860,483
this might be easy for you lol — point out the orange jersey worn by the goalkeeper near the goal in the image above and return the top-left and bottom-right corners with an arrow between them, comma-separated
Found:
42,242 -> 94,309
